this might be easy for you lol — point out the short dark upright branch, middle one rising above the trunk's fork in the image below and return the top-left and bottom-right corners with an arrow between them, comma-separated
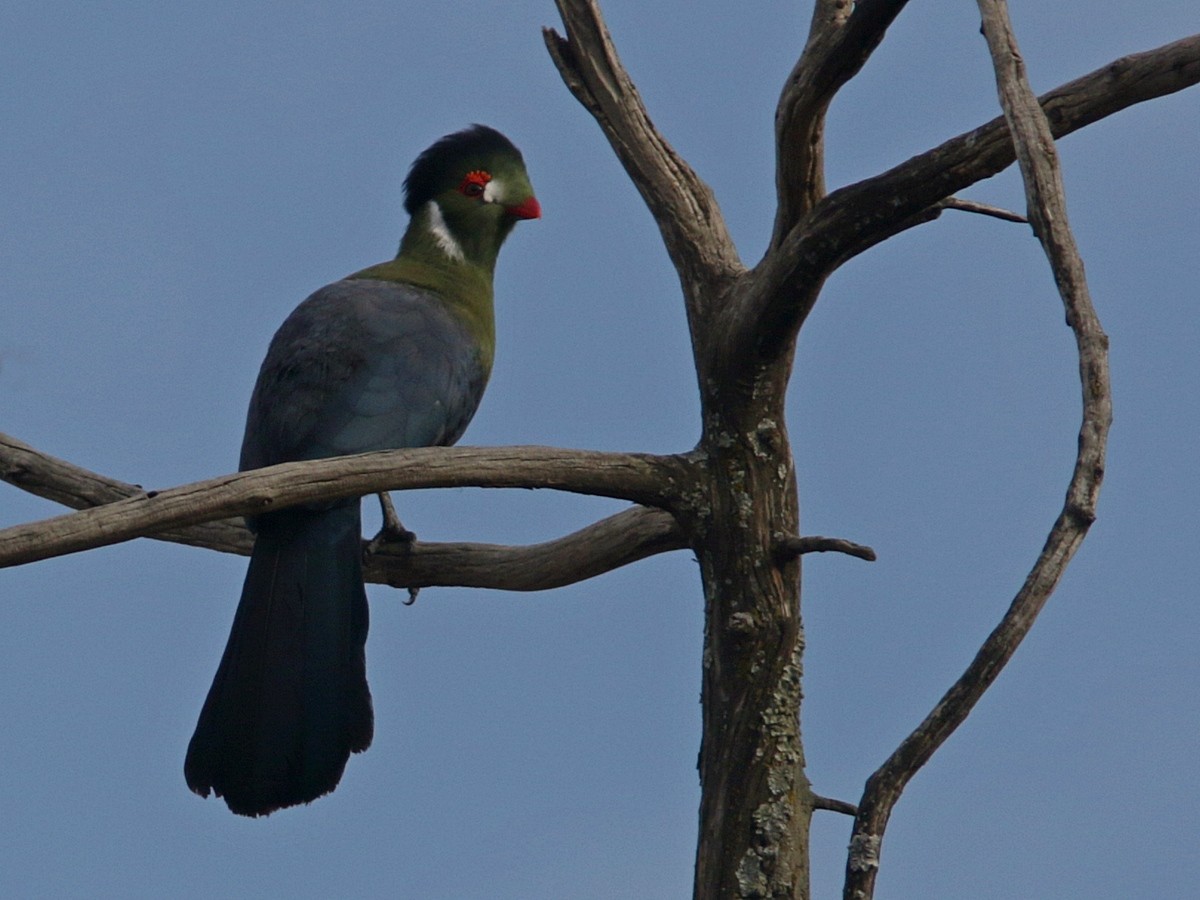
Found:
770,0 -> 907,241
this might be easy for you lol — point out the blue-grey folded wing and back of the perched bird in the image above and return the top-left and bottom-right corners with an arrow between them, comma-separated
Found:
241,280 -> 487,469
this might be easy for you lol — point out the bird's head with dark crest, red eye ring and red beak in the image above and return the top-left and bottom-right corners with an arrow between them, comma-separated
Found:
401,125 -> 541,272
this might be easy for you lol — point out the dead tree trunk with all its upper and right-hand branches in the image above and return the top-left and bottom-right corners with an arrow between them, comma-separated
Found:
546,0 -> 1200,900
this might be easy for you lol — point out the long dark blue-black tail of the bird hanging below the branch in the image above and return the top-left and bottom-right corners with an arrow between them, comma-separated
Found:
184,499 -> 374,816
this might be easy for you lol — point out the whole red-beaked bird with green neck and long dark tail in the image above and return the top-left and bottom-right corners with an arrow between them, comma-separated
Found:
184,125 -> 541,817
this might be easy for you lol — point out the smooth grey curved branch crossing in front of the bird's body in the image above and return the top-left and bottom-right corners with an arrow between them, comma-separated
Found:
0,446 -> 690,566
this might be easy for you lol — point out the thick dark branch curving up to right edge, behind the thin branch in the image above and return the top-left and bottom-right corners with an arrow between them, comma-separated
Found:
739,35 -> 1200,365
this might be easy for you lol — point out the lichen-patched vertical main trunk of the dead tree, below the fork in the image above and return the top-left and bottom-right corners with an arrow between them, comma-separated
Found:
688,364 -> 812,898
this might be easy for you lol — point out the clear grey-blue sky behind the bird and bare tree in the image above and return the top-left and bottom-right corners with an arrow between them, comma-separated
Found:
0,0 -> 1200,900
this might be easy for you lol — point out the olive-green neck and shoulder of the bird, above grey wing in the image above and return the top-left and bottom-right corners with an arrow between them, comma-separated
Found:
348,204 -> 504,371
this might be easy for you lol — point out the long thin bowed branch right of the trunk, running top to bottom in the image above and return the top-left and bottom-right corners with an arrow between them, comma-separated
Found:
844,0 -> 1112,900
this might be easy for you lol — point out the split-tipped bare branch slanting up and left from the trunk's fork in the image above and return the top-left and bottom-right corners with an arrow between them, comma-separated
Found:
542,0 -> 744,337
